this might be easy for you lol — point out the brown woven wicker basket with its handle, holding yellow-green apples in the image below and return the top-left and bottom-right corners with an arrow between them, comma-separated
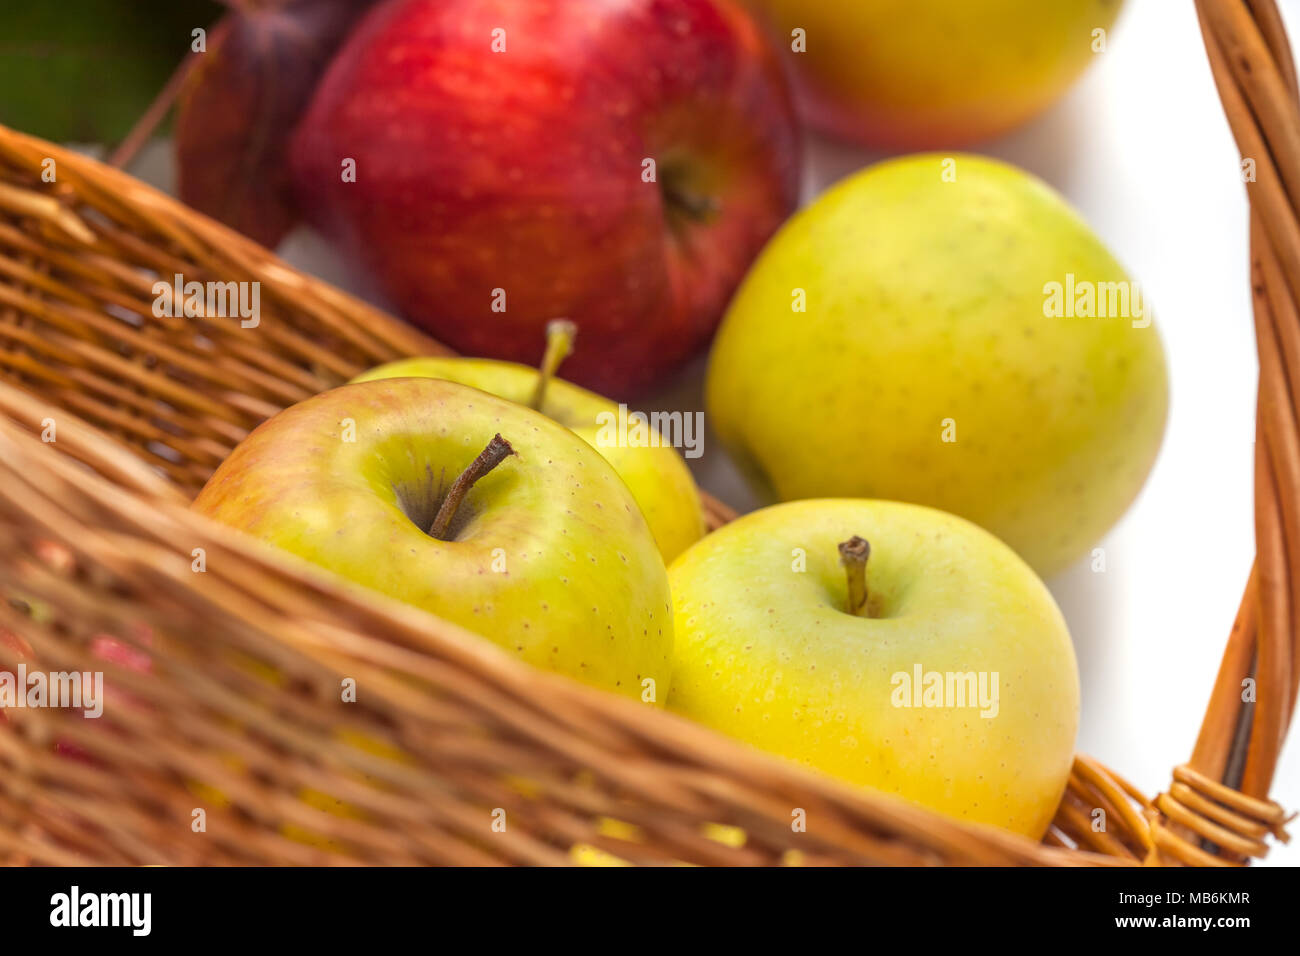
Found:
0,0 -> 1300,865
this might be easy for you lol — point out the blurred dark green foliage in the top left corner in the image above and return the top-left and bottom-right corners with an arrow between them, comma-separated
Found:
0,0 -> 224,143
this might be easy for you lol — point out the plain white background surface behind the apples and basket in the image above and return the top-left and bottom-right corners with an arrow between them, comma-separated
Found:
133,0 -> 1300,865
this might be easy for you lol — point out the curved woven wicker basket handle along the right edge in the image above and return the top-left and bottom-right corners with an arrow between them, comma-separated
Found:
1152,0 -> 1300,865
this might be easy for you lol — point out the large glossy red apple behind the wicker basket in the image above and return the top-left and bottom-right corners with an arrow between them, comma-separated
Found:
291,0 -> 800,397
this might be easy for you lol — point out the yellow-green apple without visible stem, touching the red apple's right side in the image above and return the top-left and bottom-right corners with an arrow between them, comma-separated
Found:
706,155 -> 1169,575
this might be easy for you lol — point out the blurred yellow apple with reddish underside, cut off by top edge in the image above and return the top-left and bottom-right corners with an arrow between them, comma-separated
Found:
746,0 -> 1122,150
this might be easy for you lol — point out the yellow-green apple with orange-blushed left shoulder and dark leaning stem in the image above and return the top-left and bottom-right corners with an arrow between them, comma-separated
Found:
194,378 -> 672,702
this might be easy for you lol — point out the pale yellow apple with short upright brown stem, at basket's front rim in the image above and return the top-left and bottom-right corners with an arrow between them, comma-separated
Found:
668,498 -> 1079,838
